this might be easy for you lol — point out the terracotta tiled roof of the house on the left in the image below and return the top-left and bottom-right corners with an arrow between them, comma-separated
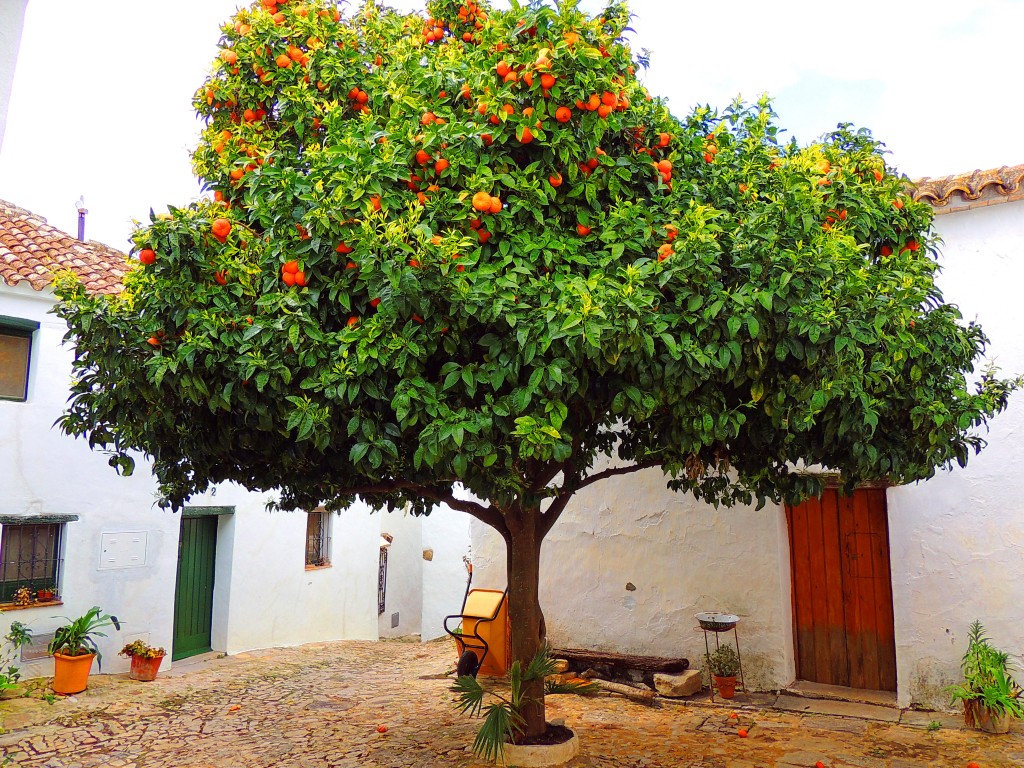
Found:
0,200 -> 129,293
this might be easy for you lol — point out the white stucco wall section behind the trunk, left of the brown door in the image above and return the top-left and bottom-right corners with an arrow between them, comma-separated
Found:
473,470 -> 793,688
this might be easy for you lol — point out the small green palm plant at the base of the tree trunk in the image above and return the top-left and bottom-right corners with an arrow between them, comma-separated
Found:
452,645 -> 597,763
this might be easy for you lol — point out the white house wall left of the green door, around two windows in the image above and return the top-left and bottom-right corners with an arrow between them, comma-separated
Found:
0,284 -> 178,676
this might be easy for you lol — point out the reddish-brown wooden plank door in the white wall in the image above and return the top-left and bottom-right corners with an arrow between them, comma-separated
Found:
785,488 -> 896,691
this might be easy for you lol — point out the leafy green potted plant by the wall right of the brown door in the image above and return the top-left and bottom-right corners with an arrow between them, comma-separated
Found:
946,621 -> 1024,733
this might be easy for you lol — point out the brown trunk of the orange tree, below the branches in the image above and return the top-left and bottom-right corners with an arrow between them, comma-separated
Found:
507,509 -> 548,738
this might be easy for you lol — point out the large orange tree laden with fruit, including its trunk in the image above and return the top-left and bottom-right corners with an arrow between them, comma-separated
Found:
58,0 -> 1017,736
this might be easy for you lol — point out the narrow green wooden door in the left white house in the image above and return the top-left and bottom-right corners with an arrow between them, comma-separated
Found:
171,515 -> 217,659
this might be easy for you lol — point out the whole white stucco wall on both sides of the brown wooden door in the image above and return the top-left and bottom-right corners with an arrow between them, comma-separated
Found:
472,196 -> 1024,708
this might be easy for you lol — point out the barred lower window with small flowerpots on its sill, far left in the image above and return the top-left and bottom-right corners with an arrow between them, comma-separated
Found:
0,520 -> 63,606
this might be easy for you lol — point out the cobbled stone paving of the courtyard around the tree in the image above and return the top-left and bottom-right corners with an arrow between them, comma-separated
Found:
0,641 -> 1024,768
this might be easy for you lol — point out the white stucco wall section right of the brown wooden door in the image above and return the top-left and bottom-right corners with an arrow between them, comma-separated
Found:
888,201 -> 1024,707
